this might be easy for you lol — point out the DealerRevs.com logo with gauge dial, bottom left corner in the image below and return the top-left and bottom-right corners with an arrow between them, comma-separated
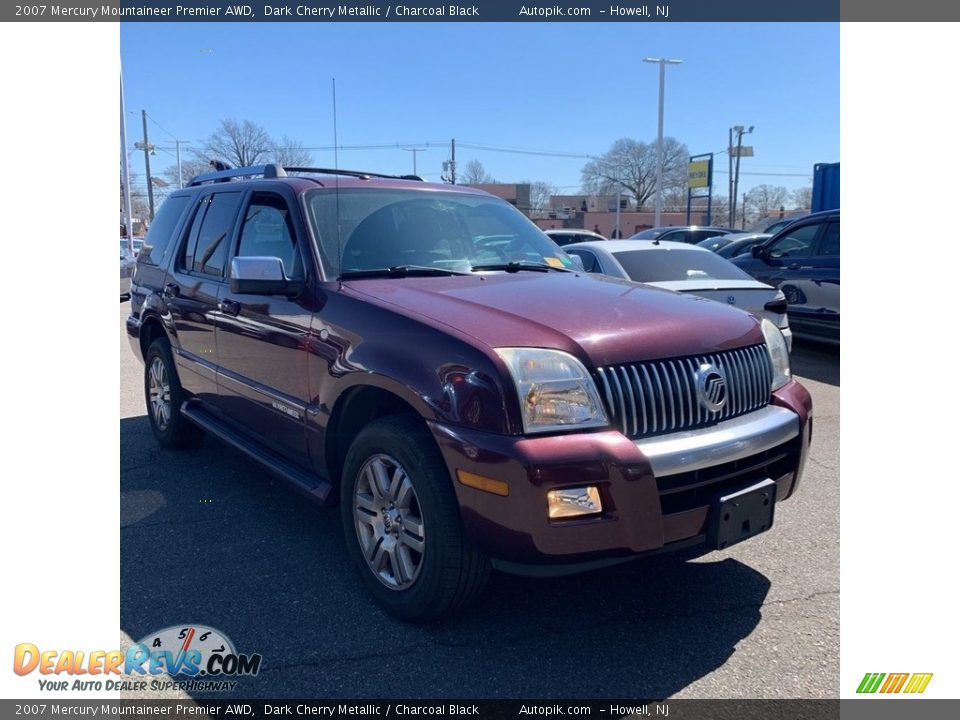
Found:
13,624 -> 263,692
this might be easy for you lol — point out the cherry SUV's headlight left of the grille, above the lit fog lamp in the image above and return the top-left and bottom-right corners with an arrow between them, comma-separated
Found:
497,348 -> 609,433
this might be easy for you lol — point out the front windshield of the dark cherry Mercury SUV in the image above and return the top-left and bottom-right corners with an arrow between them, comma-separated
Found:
305,188 -> 573,278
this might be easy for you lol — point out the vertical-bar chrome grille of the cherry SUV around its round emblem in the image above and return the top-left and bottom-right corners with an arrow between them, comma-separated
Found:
595,345 -> 773,438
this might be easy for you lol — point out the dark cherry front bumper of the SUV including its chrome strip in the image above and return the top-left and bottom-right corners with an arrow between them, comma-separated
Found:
430,382 -> 811,566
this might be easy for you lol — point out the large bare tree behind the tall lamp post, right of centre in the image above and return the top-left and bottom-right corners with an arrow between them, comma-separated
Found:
580,137 -> 690,210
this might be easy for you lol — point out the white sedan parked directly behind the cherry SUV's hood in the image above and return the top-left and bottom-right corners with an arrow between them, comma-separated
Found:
567,240 -> 793,349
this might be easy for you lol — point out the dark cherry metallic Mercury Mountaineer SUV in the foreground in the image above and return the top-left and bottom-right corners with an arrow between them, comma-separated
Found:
127,165 -> 811,620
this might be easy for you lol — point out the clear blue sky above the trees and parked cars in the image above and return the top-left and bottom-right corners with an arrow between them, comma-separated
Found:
121,22 -> 840,194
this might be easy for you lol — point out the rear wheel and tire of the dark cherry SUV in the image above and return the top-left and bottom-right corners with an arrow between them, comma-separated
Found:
143,338 -> 203,448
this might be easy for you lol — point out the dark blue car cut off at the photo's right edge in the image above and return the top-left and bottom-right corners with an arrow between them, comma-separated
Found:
732,210 -> 840,343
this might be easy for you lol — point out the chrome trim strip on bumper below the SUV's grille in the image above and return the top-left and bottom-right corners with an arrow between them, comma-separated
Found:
636,405 -> 800,477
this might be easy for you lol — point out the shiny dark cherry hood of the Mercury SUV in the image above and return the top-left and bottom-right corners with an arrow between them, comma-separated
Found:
343,272 -> 763,366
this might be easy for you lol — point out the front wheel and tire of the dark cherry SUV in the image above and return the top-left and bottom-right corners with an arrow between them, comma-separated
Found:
340,416 -> 490,622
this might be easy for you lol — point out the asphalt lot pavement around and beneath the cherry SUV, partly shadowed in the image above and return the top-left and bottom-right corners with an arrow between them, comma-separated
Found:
118,302 -> 840,699
